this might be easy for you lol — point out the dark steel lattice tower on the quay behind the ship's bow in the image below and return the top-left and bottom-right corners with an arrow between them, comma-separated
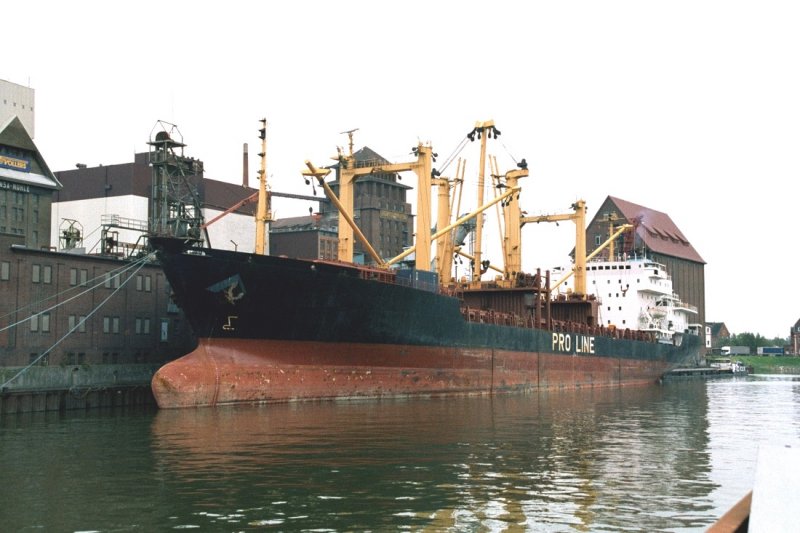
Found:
147,121 -> 208,243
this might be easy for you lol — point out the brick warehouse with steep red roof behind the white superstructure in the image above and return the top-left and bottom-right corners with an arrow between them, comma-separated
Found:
586,196 -> 706,329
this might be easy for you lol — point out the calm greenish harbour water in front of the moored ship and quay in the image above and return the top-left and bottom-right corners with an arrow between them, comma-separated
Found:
0,376 -> 800,531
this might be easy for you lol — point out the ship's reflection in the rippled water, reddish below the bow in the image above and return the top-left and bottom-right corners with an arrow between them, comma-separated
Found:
151,383 -> 715,531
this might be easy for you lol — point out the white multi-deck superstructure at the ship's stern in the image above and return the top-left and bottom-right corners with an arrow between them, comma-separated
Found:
565,258 -> 697,343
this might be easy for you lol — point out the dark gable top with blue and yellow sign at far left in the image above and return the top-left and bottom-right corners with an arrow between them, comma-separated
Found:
0,115 -> 61,189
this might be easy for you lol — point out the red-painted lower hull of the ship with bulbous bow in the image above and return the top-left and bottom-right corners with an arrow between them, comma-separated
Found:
152,339 -> 669,408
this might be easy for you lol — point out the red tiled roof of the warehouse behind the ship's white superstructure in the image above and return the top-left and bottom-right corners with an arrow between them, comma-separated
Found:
608,196 -> 705,263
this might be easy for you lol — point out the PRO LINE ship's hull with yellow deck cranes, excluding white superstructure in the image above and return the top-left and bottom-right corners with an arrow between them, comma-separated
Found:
149,121 -> 699,408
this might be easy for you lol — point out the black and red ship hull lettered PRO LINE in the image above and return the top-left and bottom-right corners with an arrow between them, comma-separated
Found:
152,238 -> 699,407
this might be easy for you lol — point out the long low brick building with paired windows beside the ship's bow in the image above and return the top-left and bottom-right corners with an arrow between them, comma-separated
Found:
0,235 -> 193,367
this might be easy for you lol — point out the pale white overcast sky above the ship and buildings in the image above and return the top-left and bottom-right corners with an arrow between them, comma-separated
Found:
6,0 -> 800,337
